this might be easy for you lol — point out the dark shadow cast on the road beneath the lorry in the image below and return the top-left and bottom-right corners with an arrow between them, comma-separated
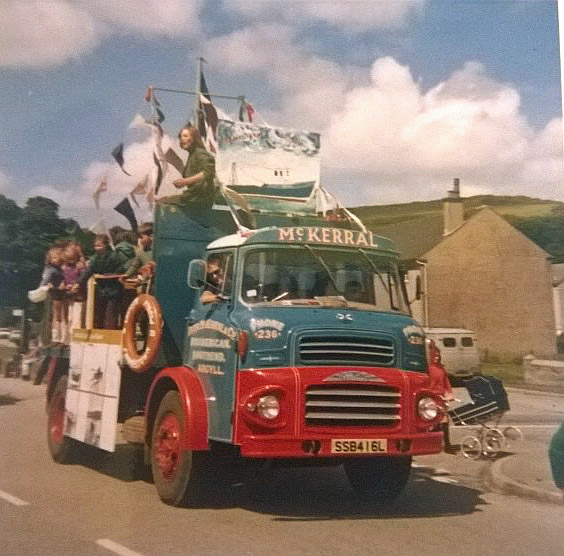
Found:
68,444 -> 486,521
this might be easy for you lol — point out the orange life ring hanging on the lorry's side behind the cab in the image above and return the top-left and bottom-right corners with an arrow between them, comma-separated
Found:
122,293 -> 163,373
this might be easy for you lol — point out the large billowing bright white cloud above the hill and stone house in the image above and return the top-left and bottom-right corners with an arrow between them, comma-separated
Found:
324,58 -> 564,202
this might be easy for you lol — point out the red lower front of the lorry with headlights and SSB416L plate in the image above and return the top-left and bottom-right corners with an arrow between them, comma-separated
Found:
233,367 -> 443,458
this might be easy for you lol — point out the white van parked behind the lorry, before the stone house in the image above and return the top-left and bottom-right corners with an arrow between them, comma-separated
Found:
424,328 -> 480,386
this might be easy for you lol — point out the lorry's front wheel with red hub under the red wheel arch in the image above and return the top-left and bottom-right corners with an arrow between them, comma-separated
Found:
151,390 -> 204,506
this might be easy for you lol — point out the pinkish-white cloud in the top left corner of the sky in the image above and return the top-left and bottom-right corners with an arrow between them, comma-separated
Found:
0,0 -> 199,68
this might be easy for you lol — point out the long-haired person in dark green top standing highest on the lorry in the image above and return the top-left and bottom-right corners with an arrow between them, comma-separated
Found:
167,126 -> 215,208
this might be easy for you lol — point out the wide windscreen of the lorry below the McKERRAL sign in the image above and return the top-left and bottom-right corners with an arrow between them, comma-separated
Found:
241,246 -> 408,313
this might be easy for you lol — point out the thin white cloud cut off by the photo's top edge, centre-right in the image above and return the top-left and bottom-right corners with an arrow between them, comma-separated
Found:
225,0 -> 425,33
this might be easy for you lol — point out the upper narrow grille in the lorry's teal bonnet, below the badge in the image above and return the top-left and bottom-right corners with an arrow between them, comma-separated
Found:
298,336 -> 395,366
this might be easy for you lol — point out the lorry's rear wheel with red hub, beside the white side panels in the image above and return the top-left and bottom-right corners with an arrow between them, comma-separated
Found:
47,375 -> 77,463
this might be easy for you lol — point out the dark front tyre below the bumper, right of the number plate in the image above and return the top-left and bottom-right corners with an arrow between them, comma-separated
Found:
345,456 -> 412,501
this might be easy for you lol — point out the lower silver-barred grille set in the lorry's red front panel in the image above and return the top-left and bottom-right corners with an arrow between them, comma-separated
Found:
305,384 -> 401,427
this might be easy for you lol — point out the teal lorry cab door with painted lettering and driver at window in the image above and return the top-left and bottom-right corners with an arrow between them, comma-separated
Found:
185,251 -> 237,441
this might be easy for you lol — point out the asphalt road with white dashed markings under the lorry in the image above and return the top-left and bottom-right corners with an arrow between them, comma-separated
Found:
0,378 -> 564,556
